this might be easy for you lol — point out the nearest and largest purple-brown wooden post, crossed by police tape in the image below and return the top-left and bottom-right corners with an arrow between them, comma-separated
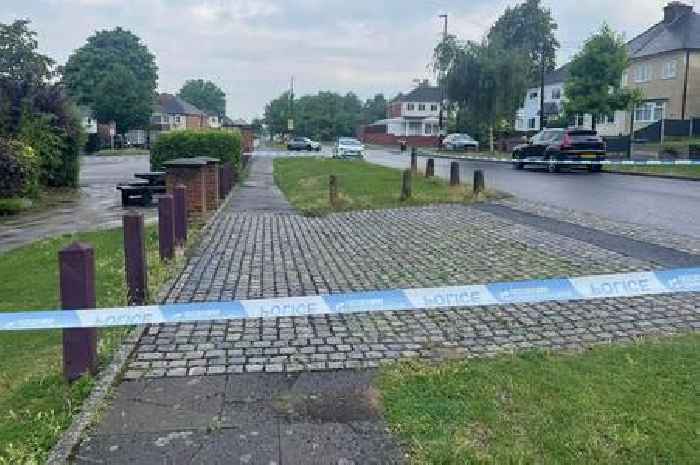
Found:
58,242 -> 97,382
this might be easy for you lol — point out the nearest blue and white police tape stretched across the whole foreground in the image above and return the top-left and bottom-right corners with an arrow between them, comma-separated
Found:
0,268 -> 700,331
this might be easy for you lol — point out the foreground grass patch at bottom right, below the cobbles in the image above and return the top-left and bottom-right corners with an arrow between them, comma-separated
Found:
379,334 -> 700,465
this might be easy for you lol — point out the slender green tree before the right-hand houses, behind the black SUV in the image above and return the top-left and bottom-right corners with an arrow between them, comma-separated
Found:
564,24 -> 640,129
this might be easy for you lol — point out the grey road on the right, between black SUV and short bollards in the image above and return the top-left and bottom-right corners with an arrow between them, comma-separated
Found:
366,150 -> 700,237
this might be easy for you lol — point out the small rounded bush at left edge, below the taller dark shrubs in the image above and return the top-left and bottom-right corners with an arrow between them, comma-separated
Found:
0,139 -> 38,197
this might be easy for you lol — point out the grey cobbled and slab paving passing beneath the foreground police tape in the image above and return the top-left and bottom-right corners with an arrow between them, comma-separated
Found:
76,157 -> 700,465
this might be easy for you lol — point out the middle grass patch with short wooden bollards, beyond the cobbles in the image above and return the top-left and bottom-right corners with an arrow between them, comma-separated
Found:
274,157 -> 492,216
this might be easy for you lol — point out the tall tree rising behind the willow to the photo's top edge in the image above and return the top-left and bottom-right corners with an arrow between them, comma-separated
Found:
487,0 -> 559,79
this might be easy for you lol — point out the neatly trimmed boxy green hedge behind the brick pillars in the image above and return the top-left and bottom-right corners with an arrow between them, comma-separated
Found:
151,129 -> 241,169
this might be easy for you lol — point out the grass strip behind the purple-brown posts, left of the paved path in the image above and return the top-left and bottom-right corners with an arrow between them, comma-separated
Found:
0,226 -> 196,465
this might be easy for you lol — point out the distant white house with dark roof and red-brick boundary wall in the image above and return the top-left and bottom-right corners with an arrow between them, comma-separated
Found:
360,80 -> 442,146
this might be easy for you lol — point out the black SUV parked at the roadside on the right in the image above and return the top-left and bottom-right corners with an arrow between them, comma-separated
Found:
513,129 -> 606,173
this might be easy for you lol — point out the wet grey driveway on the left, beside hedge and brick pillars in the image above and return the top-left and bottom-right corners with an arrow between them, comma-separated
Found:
0,155 -> 156,253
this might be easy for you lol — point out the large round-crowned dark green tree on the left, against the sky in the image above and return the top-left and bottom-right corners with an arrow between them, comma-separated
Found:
63,27 -> 158,131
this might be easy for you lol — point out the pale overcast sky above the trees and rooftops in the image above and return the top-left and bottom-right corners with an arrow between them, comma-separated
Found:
0,0 -> 666,119
